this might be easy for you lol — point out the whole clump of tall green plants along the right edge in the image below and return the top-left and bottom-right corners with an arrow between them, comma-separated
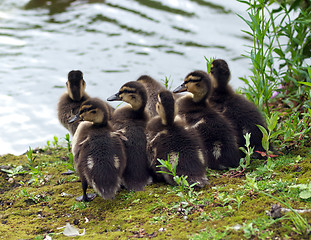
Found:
237,0 -> 311,150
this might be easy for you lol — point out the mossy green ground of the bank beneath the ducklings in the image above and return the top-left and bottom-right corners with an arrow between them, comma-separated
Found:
0,143 -> 311,240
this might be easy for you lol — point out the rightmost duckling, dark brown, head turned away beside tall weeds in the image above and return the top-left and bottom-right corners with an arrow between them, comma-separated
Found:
210,59 -> 266,155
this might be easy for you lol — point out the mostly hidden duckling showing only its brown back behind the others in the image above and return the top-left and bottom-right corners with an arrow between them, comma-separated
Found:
137,75 -> 165,118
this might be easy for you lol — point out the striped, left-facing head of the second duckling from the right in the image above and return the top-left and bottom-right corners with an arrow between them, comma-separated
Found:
173,70 -> 212,102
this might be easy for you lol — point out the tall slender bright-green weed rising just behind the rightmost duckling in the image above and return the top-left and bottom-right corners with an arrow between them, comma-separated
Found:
238,0 -> 278,116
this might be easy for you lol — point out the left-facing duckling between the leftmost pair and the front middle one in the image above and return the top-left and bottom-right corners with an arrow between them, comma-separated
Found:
107,81 -> 151,191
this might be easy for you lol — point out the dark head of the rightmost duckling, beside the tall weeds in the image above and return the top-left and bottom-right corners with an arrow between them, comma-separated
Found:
210,59 -> 230,89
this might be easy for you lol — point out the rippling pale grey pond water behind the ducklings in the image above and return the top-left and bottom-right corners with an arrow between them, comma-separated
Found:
0,0 -> 249,154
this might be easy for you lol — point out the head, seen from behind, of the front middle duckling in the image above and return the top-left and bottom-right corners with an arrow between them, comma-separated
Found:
156,90 -> 177,125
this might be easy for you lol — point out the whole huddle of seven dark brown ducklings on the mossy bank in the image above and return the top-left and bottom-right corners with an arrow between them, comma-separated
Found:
58,59 -> 265,201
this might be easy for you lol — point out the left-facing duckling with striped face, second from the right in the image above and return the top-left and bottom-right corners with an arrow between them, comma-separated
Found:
173,71 -> 240,169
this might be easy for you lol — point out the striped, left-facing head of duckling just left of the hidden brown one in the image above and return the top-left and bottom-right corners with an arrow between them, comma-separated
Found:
107,81 -> 147,111
